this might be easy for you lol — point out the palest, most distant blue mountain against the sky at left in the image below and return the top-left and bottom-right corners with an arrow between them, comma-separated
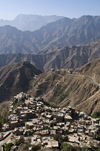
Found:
0,14 -> 63,31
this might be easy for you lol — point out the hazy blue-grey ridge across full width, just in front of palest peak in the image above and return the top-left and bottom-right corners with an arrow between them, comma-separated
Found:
0,16 -> 100,54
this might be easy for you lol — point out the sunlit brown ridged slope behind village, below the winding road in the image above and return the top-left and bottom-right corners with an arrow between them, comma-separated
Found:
28,70 -> 100,114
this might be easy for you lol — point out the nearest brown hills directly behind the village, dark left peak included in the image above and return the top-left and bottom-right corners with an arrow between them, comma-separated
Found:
0,59 -> 100,114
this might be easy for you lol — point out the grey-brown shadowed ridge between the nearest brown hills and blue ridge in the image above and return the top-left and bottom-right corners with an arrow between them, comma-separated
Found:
0,41 -> 100,72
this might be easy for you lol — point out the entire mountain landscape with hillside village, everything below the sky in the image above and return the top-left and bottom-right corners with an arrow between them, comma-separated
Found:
0,12 -> 100,151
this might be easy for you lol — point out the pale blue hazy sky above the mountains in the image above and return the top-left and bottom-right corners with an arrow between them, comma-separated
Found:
0,0 -> 100,20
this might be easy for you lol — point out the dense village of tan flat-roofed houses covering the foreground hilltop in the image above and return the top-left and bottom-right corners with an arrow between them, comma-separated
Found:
0,92 -> 100,151
